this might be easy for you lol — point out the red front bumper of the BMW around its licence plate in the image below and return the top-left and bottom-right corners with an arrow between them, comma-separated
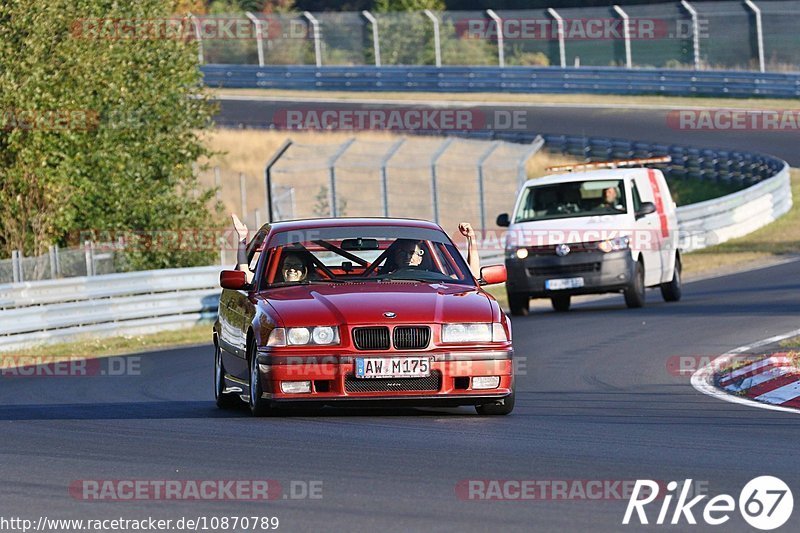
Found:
253,349 -> 513,406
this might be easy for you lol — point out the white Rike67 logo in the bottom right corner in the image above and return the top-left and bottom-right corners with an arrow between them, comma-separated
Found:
622,476 -> 794,531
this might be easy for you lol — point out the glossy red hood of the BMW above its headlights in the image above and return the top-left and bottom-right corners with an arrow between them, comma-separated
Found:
260,281 -> 492,327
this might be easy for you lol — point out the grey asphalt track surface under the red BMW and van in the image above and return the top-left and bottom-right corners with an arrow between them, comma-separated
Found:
0,261 -> 800,532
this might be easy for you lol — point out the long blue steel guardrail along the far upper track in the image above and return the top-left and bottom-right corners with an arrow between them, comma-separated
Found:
201,65 -> 800,98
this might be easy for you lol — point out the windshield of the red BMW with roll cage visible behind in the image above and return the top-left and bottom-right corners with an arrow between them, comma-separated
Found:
262,226 -> 475,287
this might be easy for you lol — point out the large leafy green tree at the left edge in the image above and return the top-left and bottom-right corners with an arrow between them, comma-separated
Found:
0,0 -> 216,269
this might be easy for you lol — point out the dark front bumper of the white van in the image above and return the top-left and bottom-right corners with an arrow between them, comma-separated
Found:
506,250 -> 635,298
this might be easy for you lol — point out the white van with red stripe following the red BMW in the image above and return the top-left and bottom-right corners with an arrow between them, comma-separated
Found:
497,164 -> 681,315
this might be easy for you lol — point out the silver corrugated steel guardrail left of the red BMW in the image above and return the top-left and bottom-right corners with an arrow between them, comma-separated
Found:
0,266 -> 220,351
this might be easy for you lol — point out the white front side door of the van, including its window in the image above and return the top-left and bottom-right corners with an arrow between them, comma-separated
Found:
631,174 -> 666,287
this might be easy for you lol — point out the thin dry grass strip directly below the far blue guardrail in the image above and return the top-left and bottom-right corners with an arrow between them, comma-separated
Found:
208,89 -> 797,109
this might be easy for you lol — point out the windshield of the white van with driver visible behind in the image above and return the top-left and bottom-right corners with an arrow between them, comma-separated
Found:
514,180 -> 627,222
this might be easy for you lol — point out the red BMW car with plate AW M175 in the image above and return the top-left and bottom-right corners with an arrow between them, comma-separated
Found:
213,218 -> 514,415
